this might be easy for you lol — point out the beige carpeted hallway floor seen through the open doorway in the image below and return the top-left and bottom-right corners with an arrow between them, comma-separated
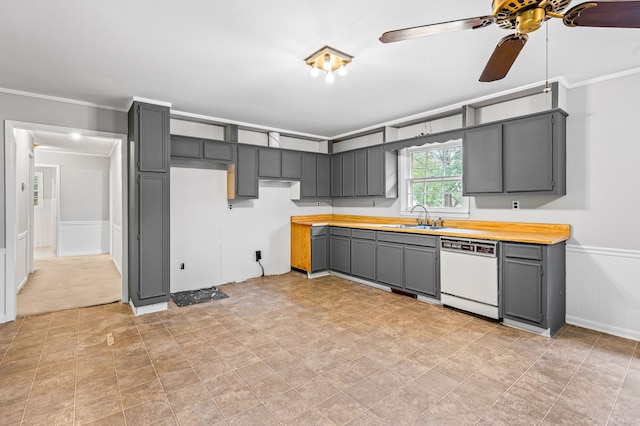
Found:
18,254 -> 122,316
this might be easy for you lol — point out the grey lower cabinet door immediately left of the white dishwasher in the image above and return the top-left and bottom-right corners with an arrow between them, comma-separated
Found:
404,246 -> 438,297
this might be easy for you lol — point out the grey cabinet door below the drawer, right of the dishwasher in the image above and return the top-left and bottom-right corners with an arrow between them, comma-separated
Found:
503,258 -> 543,325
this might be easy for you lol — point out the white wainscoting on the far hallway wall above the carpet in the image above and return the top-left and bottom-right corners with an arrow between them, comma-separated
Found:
58,220 -> 109,256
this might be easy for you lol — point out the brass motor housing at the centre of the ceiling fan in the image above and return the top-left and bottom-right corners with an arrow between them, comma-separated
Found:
492,0 -> 571,29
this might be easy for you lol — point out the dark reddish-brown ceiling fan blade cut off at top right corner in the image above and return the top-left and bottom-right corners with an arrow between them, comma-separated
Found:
563,1 -> 640,28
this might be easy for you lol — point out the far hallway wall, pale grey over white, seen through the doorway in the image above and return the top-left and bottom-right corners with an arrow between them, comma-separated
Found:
35,150 -> 110,256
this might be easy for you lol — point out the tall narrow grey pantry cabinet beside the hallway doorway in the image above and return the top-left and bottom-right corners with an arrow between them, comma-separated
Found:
128,102 -> 170,307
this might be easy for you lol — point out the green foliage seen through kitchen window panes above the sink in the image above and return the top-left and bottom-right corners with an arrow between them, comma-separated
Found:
407,144 -> 462,208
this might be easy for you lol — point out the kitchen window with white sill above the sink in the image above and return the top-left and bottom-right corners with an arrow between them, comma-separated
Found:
401,139 -> 469,217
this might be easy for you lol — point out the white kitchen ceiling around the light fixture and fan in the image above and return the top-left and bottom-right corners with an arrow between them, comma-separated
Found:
0,0 -> 640,138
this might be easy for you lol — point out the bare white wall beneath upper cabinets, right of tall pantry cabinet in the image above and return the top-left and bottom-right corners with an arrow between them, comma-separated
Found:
170,167 -> 331,292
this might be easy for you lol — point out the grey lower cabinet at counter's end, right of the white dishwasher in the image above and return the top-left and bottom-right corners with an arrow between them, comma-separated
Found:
502,243 -> 566,335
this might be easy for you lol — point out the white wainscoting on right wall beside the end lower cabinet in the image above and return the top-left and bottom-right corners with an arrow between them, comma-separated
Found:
566,245 -> 640,340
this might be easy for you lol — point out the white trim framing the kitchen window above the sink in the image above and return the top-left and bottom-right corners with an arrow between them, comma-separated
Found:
398,139 -> 469,219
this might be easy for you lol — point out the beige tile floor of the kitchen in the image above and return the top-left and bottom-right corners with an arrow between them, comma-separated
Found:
0,273 -> 640,426
